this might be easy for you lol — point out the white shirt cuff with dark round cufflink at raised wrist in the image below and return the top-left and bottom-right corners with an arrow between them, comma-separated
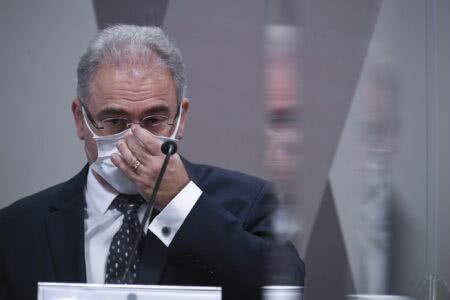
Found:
148,181 -> 203,247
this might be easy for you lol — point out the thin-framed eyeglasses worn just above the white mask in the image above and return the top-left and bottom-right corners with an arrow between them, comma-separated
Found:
83,106 -> 178,136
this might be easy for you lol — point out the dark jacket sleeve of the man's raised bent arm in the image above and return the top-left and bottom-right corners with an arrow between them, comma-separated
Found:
169,180 -> 304,288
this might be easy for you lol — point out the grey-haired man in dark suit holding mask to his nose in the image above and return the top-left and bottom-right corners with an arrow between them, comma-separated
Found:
0,25 -> 304,299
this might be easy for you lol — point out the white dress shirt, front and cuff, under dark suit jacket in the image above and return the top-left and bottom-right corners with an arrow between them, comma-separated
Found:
84,168 -> 202,283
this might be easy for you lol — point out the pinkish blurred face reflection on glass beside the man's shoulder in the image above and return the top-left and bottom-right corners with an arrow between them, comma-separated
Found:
264,1 -> 302,292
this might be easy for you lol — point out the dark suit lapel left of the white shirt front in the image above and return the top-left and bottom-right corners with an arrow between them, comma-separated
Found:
46,166 -> 88,282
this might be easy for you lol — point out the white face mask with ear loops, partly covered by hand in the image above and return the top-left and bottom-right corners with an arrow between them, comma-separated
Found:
82,105 -> 181,194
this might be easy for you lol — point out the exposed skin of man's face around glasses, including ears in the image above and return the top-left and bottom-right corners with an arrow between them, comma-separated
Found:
72,61 -> 189,163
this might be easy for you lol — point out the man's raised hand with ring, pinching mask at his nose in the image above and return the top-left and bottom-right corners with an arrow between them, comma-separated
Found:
111,125 -> 189,210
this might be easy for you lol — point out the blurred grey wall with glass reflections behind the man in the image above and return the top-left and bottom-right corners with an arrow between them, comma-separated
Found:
0,0 -> 450,299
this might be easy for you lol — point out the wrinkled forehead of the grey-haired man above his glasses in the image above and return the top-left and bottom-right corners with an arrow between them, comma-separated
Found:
90,61 -> 176,106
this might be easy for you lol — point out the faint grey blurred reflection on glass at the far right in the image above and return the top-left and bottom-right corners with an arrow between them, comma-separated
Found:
357,66 -> 399,294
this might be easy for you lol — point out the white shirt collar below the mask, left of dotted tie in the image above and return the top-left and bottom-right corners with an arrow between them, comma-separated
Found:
86,167 -> 119,214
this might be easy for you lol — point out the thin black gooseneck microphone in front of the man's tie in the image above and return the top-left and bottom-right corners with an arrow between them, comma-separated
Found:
121,140 -> 178,283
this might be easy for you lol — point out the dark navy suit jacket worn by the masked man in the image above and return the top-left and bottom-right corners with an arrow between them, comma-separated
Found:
0,160 -> 304,300
